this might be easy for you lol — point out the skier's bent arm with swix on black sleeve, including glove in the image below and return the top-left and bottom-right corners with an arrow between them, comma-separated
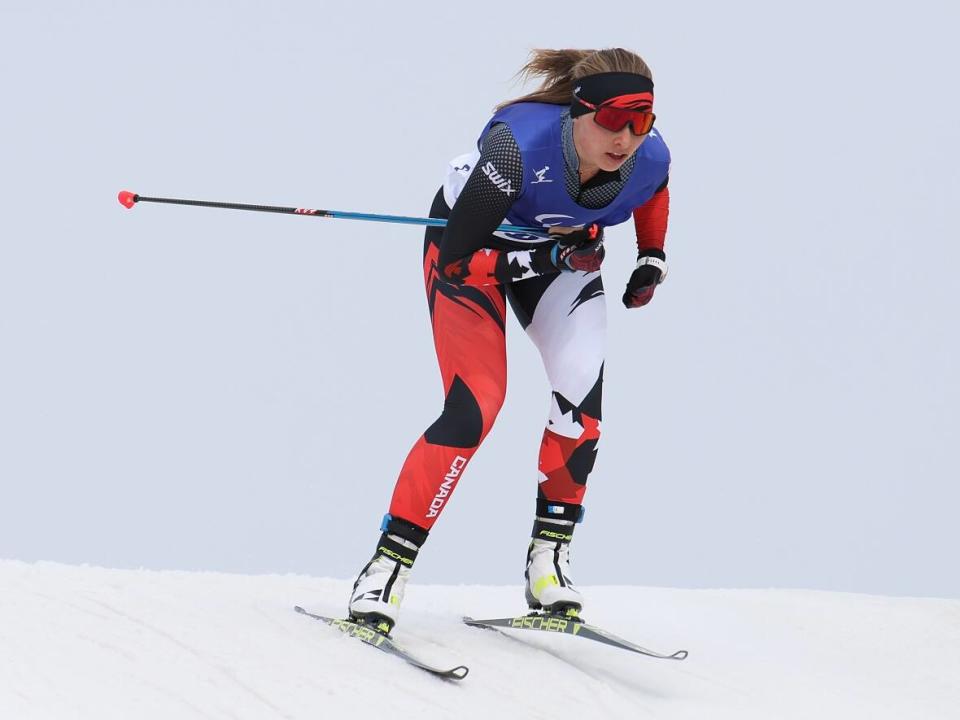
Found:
438,124 -> 558,285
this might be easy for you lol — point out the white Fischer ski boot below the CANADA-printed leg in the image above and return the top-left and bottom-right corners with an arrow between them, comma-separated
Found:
348,515 -> 427,635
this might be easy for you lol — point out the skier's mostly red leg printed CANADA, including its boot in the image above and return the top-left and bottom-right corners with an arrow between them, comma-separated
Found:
350,188 -> 507,630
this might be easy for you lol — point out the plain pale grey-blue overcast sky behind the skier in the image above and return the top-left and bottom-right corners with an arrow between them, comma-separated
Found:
0,0 -> 960,602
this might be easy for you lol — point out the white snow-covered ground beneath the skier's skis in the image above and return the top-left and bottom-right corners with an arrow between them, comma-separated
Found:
0,561 -> 960,720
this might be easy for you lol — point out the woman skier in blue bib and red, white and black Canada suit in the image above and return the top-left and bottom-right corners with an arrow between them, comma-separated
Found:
349,48 -> 670,632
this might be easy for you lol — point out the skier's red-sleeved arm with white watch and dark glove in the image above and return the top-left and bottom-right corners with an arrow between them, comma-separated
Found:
623,178 -> 670,308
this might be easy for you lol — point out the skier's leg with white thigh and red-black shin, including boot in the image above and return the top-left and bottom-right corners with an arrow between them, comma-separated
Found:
508,272 -> 606,610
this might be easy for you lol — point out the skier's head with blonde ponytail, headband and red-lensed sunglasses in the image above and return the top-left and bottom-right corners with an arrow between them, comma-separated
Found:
498,48 -> 654,171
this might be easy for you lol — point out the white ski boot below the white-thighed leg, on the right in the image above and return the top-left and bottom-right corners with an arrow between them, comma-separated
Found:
524,498 -> 583,618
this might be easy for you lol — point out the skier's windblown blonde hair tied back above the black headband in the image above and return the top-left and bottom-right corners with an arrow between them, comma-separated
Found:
494,48 -> 653,112
